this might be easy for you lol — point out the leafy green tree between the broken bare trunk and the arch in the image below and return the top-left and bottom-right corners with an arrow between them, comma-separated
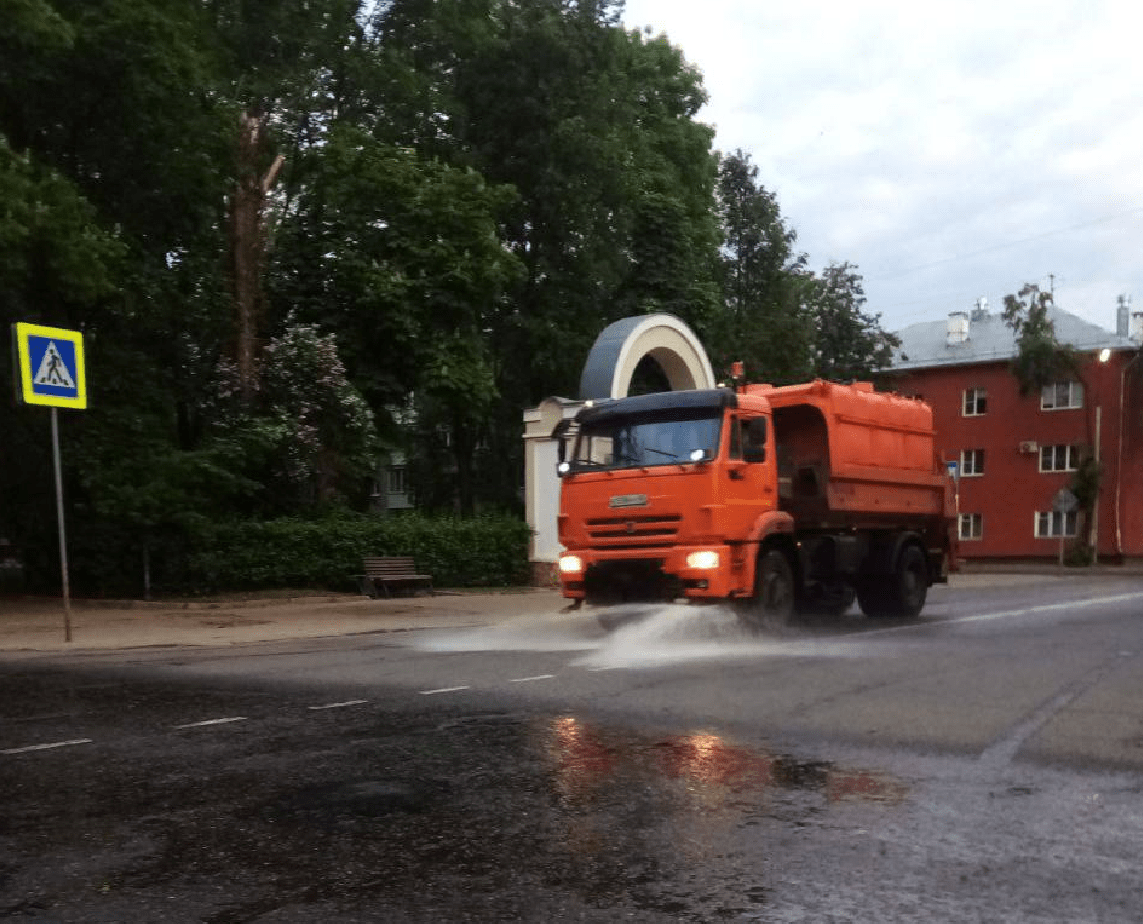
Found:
275,127 -> 520,511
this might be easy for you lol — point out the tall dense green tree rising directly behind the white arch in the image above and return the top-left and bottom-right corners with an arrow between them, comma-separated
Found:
441,0 -> 717,400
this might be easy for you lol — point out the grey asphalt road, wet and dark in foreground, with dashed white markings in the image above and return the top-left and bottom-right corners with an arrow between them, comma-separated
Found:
0,579 -> 1143,924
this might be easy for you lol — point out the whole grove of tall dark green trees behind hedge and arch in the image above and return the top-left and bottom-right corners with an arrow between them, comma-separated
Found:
0,0 -> 885,587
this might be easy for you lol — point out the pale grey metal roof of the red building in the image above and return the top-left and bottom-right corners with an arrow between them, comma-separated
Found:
890,306 -> 1140,369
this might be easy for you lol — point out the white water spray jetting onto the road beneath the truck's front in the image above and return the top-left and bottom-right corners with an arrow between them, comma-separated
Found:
411,604 -> 871,669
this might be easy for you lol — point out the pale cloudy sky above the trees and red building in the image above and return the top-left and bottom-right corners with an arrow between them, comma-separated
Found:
624,0 -> 1143,330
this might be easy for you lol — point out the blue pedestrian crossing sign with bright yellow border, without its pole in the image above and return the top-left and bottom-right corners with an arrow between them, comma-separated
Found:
14,321 -> 87,411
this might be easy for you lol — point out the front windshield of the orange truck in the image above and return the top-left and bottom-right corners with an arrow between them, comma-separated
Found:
570,408 -> 721,471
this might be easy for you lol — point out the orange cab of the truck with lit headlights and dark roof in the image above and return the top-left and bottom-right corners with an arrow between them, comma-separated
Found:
559,389 -> 792,603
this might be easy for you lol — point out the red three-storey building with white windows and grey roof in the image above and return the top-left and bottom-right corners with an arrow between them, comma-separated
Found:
893,308 -> 1143,561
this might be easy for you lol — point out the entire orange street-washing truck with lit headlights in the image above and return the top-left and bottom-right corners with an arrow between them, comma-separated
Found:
559,380 -> 954,626
